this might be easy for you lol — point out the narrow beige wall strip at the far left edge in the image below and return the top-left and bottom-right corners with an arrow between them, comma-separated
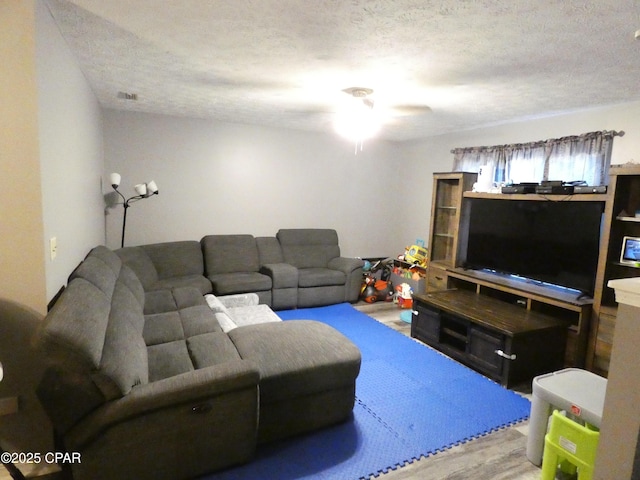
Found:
0,0 -> 47,313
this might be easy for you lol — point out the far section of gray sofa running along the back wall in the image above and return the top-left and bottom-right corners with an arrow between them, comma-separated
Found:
116,229 -> 363,310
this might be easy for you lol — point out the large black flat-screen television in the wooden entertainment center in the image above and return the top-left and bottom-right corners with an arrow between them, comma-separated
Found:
465,198 -> 604,296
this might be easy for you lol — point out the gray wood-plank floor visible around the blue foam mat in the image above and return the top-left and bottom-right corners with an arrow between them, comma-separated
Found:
355,302 -> 540,480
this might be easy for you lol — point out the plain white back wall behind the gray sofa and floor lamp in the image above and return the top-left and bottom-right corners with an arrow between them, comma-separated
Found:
104,110 -> 412,257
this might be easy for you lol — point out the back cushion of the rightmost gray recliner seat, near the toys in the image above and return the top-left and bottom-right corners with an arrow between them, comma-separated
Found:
276,228 -> 340,268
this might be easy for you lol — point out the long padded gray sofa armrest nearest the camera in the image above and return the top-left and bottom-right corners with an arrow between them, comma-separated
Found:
65,360 -> 260,449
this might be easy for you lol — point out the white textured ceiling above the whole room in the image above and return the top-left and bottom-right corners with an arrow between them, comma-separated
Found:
46,0 -> 640,141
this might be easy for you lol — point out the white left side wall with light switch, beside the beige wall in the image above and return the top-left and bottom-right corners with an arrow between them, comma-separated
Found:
36,2 -> 105,300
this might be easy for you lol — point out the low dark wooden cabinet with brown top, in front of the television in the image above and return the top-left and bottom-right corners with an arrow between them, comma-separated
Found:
411,289 -> 570,387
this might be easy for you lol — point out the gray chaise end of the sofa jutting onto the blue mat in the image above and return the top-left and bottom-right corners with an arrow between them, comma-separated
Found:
229,320 -> 361,443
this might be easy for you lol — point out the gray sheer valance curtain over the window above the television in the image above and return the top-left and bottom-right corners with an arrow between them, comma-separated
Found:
451,130 -> 624,185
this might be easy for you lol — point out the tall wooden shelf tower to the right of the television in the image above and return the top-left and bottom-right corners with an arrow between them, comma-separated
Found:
586,165 -> 640,376
